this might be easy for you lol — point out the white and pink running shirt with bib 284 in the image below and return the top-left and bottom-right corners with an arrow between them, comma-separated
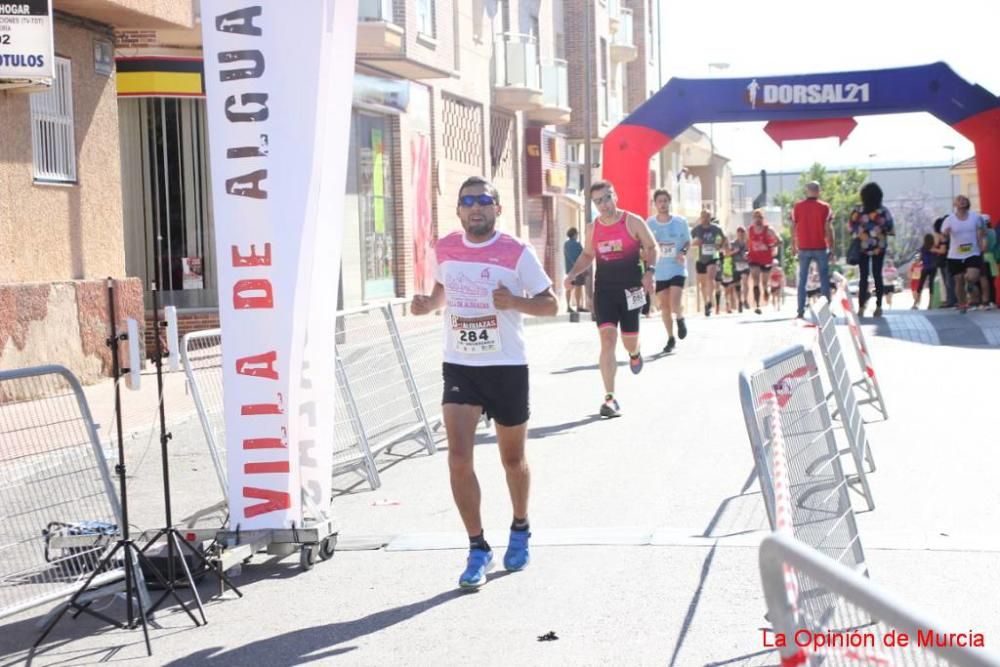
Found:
434,232 -> 552,366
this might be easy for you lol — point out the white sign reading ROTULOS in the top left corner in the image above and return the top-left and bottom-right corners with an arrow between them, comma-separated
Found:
0,0 -> 55,83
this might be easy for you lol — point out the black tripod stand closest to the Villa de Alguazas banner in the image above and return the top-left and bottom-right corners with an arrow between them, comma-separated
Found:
143,282 -> 243,625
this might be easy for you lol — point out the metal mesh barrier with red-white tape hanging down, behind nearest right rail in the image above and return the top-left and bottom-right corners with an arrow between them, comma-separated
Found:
740,345 -> 867,574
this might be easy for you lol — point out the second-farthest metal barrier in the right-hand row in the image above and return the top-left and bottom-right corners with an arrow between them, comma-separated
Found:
809,300 -> 875,510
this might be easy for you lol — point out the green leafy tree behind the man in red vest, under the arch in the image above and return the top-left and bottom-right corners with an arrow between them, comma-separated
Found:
773,162 -> 868,268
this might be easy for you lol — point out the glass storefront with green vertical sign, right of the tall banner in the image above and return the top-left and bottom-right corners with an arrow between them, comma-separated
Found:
354,112 -> 396,301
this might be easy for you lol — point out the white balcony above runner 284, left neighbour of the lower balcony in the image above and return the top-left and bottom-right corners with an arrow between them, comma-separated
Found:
493,33 -> 543,111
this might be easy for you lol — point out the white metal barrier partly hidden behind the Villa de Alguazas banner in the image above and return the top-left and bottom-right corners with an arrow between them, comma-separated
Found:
181,329 -> 380,500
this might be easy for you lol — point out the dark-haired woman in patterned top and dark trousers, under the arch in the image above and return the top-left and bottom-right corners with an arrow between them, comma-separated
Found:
847,182 -> 895,317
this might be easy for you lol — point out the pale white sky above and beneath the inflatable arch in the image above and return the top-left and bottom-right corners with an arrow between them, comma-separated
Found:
654,0 -> 1000,174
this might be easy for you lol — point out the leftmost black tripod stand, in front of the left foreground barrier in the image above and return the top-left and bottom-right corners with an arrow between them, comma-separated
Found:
33,278 -> 198,656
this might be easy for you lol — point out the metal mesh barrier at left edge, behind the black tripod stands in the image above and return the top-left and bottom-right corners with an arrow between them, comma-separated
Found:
0,366 -> 135,617
